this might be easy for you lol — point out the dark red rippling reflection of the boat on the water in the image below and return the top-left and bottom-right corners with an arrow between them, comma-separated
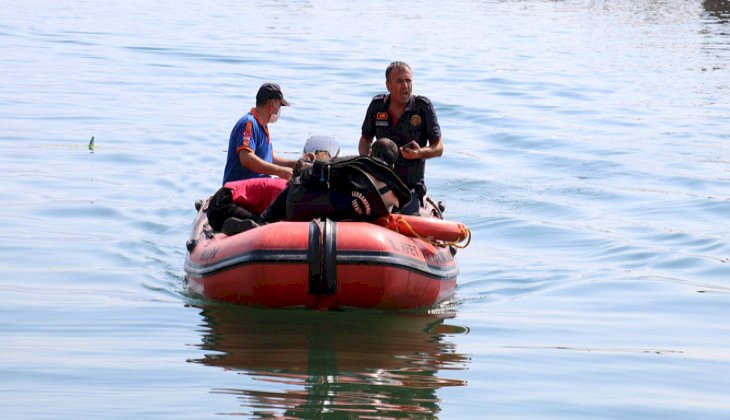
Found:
191,305 -> 468,418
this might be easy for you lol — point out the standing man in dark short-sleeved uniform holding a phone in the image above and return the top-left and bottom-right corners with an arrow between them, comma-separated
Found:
358,61 -> 444,212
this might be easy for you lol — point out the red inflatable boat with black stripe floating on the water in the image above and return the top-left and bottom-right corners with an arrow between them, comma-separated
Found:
185,199 -> 471,309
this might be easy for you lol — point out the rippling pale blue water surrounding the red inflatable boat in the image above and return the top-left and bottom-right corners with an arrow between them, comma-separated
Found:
0,0 -> 730,419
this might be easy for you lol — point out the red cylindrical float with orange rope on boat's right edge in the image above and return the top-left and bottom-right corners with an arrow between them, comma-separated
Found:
375,214 -> 471,248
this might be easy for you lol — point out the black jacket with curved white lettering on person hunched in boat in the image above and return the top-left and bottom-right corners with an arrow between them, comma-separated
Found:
286,156 -> 411,221
